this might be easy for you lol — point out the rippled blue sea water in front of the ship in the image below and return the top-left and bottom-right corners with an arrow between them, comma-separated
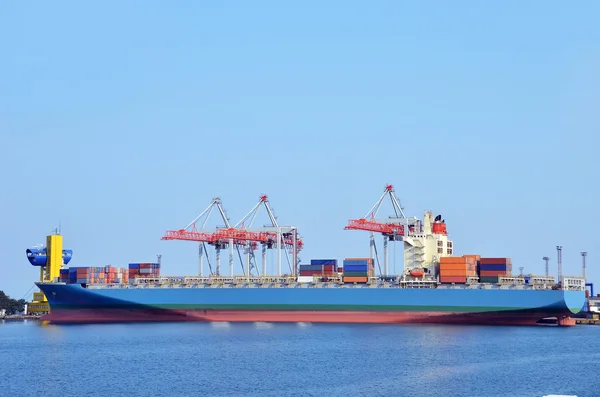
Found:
0,321 -> 600,397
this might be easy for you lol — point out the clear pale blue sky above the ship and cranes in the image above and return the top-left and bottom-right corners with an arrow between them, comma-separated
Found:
0,1 -> 600,298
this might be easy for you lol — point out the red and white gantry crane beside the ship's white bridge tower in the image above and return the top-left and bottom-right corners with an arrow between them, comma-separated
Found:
344,185 -> 414,276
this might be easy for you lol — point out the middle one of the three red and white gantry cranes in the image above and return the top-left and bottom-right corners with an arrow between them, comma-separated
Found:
235,195 -> 303,276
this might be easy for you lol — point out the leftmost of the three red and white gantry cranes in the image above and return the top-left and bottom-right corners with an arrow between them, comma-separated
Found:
161,197 -> 240,277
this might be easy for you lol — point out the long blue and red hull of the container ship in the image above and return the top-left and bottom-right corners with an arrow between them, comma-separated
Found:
38,278 -> 584,325
